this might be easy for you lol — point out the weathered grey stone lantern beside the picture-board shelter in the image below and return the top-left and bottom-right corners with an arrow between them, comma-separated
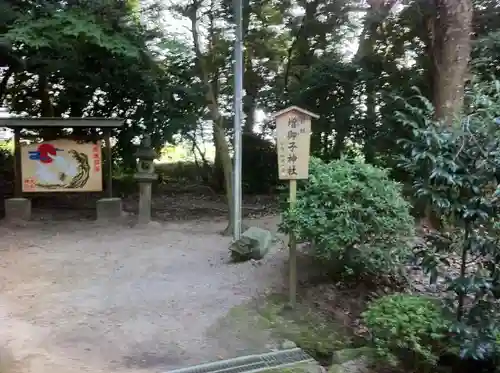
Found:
134,135 -> 158,224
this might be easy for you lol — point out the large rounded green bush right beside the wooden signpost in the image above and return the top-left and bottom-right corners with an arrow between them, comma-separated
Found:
280,158 -> 414,275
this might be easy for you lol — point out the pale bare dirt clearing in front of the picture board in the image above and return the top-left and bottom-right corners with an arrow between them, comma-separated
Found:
0,218 -> 286,373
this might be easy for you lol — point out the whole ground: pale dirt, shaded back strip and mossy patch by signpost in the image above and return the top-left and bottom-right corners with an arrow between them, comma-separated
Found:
0,189 -> 376,373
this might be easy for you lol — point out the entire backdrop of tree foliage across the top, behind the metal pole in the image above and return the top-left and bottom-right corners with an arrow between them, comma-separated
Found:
0,0 -> 494,198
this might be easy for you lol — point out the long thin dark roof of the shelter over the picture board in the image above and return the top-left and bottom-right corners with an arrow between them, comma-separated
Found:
0,117 -> 125,128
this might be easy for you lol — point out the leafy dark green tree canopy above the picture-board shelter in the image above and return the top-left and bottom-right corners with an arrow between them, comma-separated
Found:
0,0 -> 203,171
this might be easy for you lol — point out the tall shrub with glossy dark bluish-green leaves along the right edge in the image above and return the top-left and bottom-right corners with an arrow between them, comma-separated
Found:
399,81 -> 500,360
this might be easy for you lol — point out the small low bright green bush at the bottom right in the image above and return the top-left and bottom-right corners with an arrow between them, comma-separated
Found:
362,294 -> 449,371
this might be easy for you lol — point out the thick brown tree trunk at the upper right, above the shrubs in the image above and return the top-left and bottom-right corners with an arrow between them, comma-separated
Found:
431,0 -> 473,125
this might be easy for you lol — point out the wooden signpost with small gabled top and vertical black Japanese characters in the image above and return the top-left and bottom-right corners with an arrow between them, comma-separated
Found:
273,106 -> 319,308
